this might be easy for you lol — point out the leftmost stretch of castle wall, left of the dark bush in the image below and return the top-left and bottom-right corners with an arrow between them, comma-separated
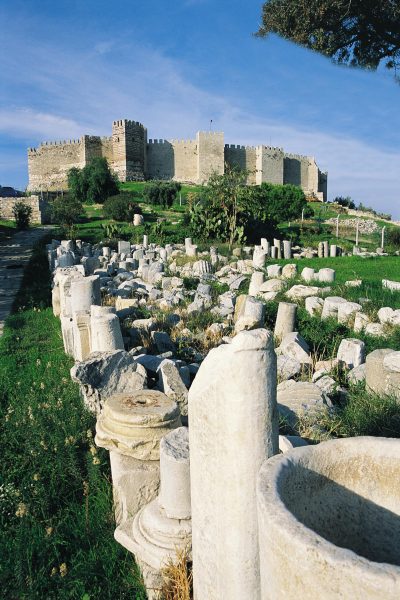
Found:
28,136 -> 85,192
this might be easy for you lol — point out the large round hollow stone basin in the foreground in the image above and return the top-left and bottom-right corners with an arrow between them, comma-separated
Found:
257,437 -> 400,600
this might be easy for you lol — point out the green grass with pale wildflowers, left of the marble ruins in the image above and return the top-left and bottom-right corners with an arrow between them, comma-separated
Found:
0,239 -> 145,600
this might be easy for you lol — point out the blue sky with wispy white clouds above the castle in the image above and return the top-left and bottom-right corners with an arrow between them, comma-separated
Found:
0,0 -> 400,219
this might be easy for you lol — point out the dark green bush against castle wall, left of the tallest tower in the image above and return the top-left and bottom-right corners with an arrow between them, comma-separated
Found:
68,158 -> 118,204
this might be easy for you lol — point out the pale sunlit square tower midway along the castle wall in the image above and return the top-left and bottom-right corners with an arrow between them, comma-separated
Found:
196,131 -> 225,183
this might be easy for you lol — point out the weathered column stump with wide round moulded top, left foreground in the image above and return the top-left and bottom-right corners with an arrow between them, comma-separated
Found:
95,390 -> 181,524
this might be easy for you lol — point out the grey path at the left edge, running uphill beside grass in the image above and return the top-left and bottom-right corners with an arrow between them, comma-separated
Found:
0,225 -> 51,337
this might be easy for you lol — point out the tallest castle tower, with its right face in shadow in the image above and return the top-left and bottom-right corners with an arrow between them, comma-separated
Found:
112,119 -> 147,181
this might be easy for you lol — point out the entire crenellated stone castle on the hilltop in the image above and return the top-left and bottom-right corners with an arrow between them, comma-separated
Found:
28,119 -> 327,201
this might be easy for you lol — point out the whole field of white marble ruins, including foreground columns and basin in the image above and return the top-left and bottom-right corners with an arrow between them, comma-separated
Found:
47,229 -> 400,600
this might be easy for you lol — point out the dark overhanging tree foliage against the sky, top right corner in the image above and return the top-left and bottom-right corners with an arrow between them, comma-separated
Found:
258,0 -> 400,77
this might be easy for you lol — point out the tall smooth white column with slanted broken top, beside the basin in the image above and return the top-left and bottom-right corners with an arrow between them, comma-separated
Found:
189,329 -> 278,600
